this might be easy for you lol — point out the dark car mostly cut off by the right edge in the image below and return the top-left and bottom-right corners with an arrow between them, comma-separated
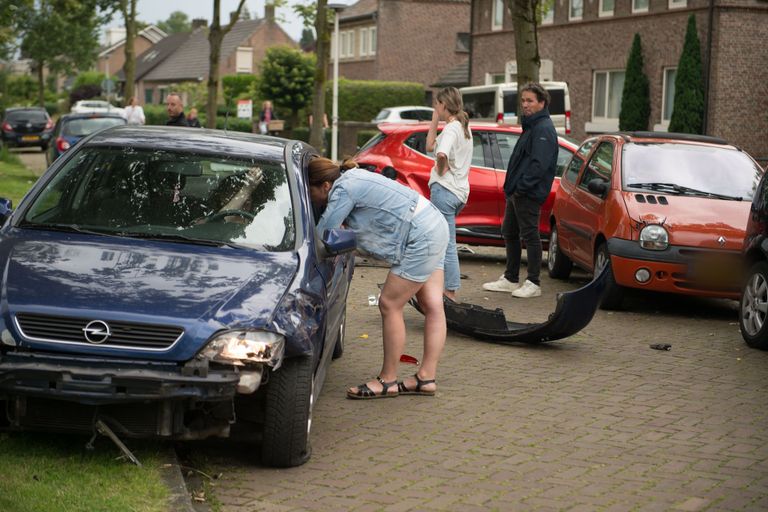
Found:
739,166 -> 768,350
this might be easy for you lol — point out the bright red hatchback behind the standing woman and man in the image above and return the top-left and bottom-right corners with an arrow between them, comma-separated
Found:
355,122 -> 578,246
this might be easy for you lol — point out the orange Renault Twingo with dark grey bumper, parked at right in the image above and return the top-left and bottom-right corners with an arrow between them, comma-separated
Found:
547,132 -> 762,309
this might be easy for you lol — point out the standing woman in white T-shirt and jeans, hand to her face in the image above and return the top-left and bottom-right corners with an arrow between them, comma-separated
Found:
427,87 -> 472,300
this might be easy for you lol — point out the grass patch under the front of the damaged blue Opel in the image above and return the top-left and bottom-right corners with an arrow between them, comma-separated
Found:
0,433 -> 169,512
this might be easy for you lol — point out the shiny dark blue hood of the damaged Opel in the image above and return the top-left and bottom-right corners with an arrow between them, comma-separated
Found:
0,229 -> 298,361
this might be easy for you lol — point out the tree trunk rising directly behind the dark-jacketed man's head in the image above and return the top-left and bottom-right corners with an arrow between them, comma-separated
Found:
510,0 -> 541,94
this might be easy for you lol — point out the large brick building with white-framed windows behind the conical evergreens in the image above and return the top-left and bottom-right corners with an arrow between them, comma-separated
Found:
470,0 -> 768,163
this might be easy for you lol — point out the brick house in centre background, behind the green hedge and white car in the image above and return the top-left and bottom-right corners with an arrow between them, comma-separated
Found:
328,0 -> 470,93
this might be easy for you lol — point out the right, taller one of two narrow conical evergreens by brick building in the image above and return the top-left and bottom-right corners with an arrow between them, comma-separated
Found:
669,14 -> 706,134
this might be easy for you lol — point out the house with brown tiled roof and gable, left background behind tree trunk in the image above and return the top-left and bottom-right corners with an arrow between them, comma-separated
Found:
136,7 -> 298,103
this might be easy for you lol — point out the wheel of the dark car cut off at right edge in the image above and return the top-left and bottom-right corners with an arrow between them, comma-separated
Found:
739,261 -> 768,350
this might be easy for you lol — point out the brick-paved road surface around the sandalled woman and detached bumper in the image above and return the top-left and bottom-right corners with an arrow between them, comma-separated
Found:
192,249 -> 768,512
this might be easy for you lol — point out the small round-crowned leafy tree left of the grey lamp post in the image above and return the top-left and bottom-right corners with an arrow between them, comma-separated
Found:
259,46 -> 316,128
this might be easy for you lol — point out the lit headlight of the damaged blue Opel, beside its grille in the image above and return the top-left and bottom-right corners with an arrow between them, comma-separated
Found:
200,331 -> 285,369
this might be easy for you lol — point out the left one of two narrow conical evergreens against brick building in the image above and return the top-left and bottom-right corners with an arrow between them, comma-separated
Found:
619,34 -> 651,131
